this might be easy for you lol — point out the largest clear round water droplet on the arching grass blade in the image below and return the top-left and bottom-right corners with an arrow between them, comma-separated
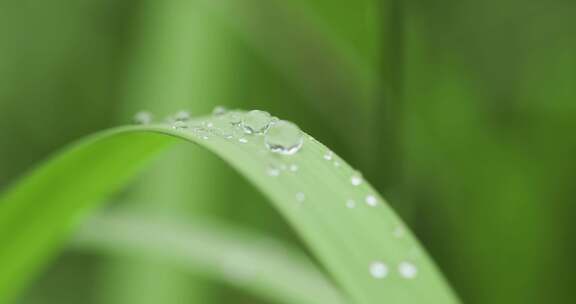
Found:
264,120 -> 304,155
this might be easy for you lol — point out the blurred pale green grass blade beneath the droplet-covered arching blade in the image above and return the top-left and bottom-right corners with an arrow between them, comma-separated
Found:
72,214 -> 346,304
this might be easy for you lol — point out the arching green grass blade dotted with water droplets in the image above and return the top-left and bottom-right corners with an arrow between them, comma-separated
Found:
0,114 -> 457,303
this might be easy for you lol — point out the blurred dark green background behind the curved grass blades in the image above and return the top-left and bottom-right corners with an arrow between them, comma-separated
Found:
0,0 -> 576,304
